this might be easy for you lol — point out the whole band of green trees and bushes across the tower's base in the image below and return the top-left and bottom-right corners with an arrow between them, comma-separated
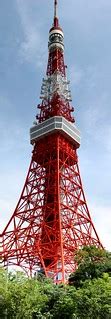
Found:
0,247 -> 111,319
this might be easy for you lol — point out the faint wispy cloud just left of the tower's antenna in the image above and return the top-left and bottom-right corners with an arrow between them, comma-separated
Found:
16,0 -> 47,67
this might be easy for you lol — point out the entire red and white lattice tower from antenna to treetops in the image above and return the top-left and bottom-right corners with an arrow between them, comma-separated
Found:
0,0 -> 102,282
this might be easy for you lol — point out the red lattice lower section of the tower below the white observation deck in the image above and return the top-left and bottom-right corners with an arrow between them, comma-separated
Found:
0,134 -> 102,282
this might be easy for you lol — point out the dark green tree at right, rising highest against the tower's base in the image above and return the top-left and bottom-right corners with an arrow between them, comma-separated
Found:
69,246 -> 111,288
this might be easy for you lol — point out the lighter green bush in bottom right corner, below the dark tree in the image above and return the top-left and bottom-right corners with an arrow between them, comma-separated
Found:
76,275 -> 111,319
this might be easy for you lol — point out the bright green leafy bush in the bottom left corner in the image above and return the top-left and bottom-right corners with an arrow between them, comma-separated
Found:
0,270 -> 48,319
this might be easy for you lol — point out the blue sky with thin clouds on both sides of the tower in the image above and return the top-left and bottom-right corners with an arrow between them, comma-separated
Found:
0,0 -> 111,250
